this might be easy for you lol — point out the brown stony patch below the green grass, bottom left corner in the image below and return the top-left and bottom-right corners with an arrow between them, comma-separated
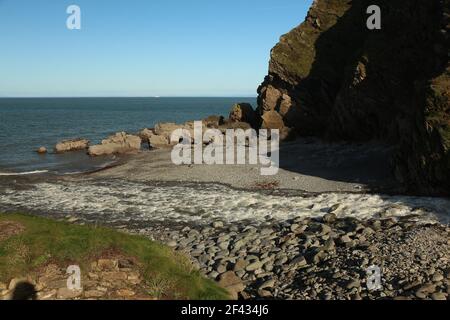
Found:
0,257 -> 151,300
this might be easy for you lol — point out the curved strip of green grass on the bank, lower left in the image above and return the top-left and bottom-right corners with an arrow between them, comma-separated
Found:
0,214 -> 228,300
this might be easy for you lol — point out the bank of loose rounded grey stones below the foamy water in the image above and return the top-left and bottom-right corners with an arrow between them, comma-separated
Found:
140,213 -> 450,300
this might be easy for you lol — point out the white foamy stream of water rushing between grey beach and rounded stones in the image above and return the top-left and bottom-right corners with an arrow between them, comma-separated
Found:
0,180 -> 450,223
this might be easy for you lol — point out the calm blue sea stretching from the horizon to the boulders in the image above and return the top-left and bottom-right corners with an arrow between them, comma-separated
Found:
0,98 -> 256,175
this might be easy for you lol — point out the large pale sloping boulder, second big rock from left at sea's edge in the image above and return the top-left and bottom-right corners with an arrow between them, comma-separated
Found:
88,132 -> 142,156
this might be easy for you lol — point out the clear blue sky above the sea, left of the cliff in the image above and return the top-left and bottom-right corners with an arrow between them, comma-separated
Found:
0,0 -> 312,97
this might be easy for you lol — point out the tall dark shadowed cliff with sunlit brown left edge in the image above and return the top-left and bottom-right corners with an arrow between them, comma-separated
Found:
258,0 -> 450,194
